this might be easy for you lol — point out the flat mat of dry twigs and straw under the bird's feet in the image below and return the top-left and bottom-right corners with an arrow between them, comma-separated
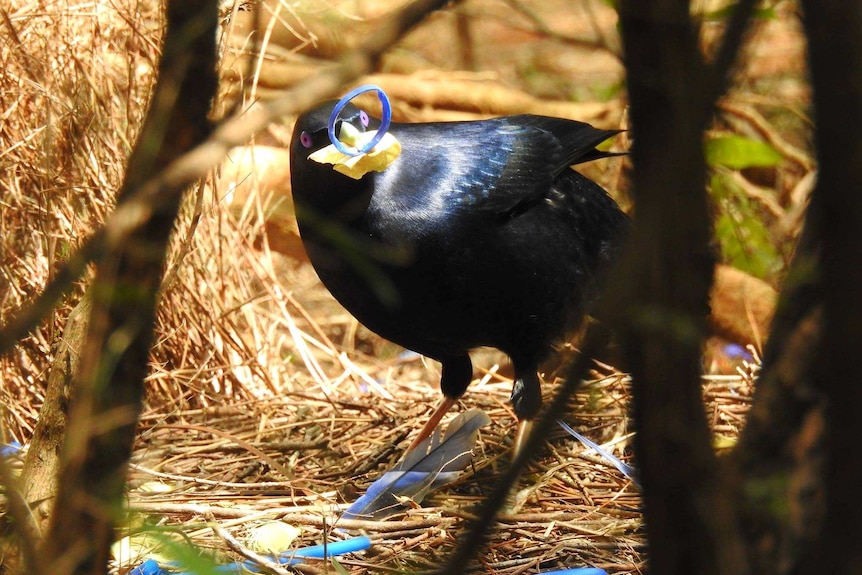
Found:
125,374 -> 643,573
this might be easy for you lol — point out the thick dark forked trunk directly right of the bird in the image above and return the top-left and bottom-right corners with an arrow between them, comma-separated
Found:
613,0 -> 760,575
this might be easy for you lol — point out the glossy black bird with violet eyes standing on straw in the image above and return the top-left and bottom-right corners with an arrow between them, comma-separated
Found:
290,102 -> 629,449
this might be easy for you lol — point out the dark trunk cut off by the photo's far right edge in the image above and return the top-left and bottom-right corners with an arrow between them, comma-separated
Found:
800,0 -> 862,573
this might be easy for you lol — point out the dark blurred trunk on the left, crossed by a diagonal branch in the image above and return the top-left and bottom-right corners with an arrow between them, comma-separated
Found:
42,0 -> 218,575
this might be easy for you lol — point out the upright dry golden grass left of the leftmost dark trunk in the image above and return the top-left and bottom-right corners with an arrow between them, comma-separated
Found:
0,0 -> 161,439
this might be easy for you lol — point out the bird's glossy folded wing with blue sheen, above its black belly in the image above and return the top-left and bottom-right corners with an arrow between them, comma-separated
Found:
380,115 -> 617,219
